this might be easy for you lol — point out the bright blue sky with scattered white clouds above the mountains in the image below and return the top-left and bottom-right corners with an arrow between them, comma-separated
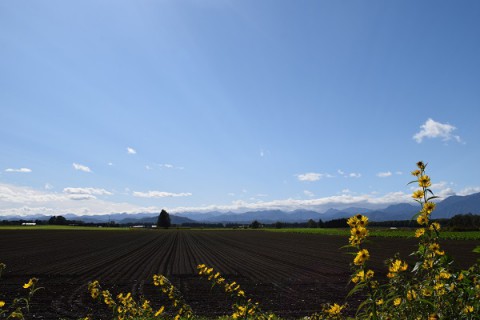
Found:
0,0 -> 480,215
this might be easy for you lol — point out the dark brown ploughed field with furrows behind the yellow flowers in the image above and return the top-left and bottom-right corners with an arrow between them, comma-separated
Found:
0,229 -> 480,319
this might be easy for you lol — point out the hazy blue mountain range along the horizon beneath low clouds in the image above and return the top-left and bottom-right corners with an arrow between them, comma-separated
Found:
0,192 -> 480,224
